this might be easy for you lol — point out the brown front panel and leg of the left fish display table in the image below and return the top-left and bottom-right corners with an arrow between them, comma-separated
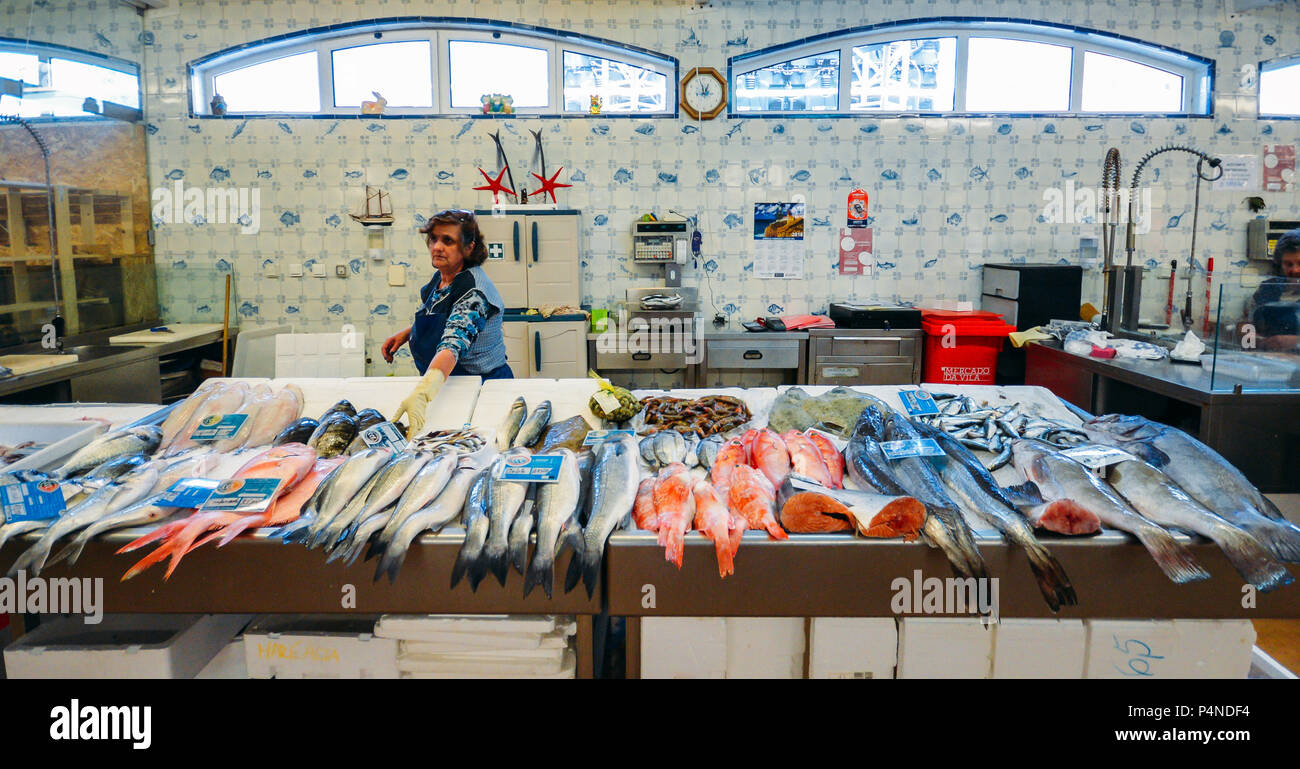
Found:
0,527 -> 603,678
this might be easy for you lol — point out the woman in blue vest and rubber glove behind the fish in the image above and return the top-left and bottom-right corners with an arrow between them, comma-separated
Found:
381,209 -> 515,436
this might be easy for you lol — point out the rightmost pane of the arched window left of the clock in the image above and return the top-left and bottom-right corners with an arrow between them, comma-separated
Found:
564,51 -> 668,112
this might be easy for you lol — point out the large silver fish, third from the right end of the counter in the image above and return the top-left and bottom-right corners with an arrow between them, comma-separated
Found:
1011,439 -> 1209,583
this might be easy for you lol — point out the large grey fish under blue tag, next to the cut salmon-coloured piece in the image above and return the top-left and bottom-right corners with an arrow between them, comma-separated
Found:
885,413 -> 988,579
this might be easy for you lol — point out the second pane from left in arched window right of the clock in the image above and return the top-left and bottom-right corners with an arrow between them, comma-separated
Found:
849,38 -> 957,112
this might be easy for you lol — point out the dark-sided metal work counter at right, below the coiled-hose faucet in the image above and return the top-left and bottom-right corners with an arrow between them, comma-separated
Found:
1024,342 -> 1300,492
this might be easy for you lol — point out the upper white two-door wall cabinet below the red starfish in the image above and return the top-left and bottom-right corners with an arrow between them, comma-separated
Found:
476,210 -> 582,308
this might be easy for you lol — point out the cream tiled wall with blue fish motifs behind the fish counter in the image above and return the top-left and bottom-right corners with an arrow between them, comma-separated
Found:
0,0 -> 1300,374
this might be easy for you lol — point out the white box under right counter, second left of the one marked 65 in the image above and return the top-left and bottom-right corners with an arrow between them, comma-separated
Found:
898,617 -> 993,678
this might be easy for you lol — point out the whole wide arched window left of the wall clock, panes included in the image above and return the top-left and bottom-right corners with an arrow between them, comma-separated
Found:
190,18 -> 677,117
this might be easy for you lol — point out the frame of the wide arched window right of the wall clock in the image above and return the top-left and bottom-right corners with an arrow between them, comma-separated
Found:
727,17 -> 1214,118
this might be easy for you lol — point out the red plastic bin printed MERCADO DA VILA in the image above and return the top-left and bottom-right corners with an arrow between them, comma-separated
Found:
920,309 -> 1015,385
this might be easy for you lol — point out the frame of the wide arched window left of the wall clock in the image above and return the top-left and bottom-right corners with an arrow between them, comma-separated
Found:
186,17 -> 680,120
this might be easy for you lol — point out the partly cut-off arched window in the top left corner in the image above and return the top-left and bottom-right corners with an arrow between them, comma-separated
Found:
0,38 -> 140,120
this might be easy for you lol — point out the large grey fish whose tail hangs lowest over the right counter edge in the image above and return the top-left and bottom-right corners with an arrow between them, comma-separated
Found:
913,422 -> 1079,612
